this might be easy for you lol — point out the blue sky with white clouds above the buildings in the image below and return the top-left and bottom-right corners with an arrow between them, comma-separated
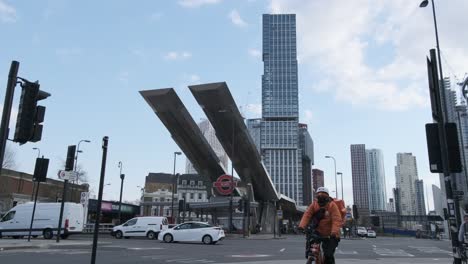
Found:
0,0 -> 468,208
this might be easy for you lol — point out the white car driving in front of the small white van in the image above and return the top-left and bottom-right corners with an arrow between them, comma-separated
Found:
158,222 -> 225,244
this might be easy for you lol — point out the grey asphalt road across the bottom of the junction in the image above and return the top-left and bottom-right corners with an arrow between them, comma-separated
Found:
0,236 -> 450,264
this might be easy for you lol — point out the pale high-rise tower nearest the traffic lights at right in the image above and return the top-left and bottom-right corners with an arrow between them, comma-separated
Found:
395,153 -> 418,215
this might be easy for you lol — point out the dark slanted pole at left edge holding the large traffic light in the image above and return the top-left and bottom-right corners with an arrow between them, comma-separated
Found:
0,61 -> 19,175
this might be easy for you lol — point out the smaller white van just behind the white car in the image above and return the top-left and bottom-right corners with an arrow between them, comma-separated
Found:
111,216 -> 169,239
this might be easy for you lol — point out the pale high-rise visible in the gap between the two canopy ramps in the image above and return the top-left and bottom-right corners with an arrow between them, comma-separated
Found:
185,119 -> 229,174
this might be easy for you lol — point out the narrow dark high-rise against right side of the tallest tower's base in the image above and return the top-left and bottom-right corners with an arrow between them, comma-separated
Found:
299,124 -> 314,205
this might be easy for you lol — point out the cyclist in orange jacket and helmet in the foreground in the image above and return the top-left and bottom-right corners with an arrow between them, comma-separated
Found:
299,187 -> 343,264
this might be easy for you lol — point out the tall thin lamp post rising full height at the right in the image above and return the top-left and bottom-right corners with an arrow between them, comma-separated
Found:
419,0 -> 461,264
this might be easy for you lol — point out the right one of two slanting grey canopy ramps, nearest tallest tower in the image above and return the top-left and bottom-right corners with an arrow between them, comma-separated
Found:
189,82 -> 280,201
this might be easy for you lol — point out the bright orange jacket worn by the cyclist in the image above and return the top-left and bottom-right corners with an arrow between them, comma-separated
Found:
299,200 -> 343,237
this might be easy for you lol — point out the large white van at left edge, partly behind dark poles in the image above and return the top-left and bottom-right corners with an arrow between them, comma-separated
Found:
0,202 -> 83,239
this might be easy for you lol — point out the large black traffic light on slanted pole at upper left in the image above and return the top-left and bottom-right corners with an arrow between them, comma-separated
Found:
13,80 -> 50,145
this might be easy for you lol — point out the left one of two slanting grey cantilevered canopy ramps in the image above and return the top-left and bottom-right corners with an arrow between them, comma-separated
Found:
140,88 -> 227,182
